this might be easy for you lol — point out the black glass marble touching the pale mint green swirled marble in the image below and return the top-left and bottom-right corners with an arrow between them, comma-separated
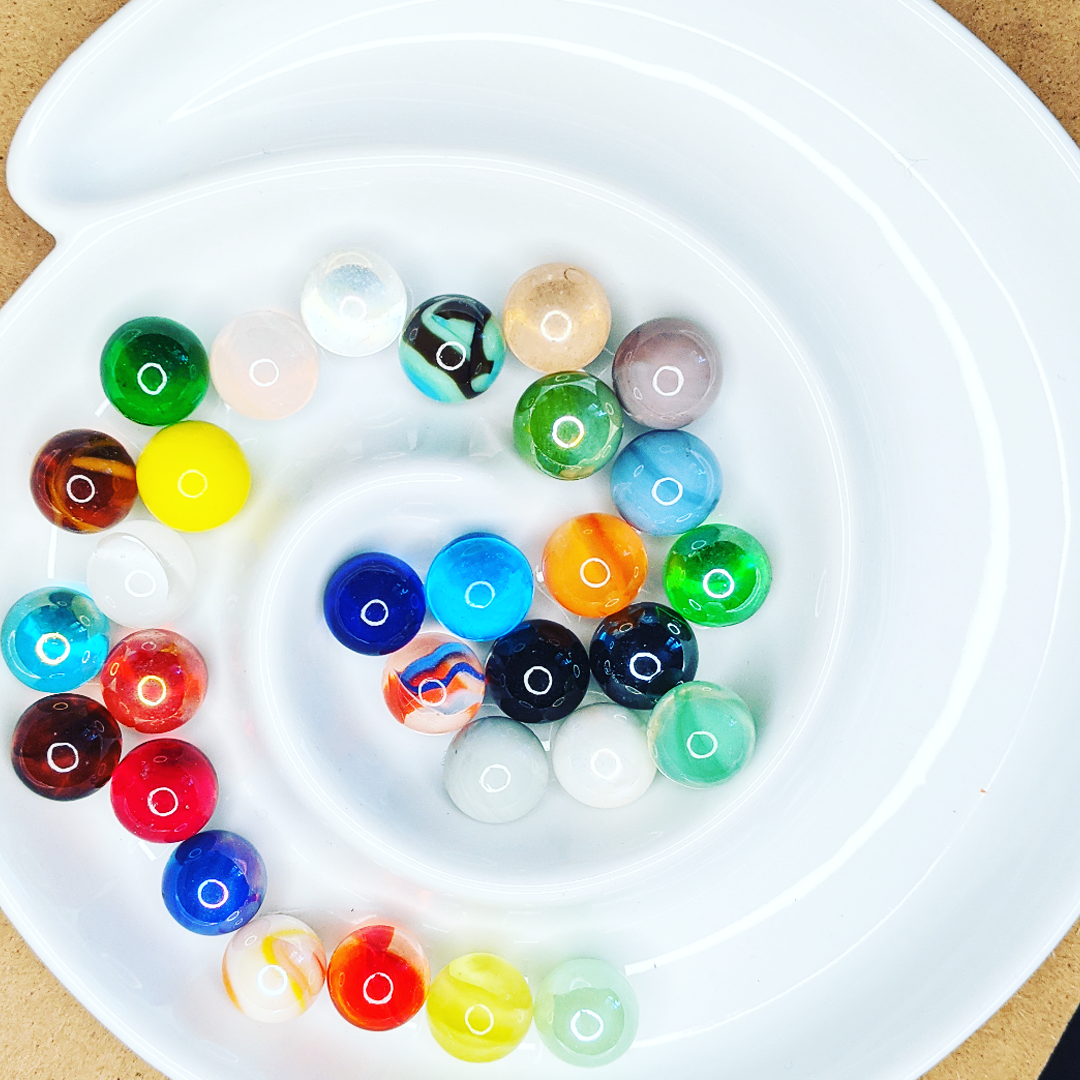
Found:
589,603 -> 698,708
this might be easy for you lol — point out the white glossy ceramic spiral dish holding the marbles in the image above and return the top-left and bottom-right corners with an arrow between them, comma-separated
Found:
0,0 -> 1080,1080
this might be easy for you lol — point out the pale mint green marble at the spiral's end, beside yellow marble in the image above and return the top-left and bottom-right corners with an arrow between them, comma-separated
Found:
532,957 -> 638,1067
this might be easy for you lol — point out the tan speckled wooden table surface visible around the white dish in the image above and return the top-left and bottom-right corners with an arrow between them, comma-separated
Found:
0,0 -> 1080,1080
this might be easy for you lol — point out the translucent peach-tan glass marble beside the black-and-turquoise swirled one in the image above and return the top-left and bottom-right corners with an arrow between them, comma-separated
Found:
502,262 -> 611,373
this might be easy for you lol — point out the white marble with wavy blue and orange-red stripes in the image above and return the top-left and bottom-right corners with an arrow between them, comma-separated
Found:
382,634 -> 485,735
